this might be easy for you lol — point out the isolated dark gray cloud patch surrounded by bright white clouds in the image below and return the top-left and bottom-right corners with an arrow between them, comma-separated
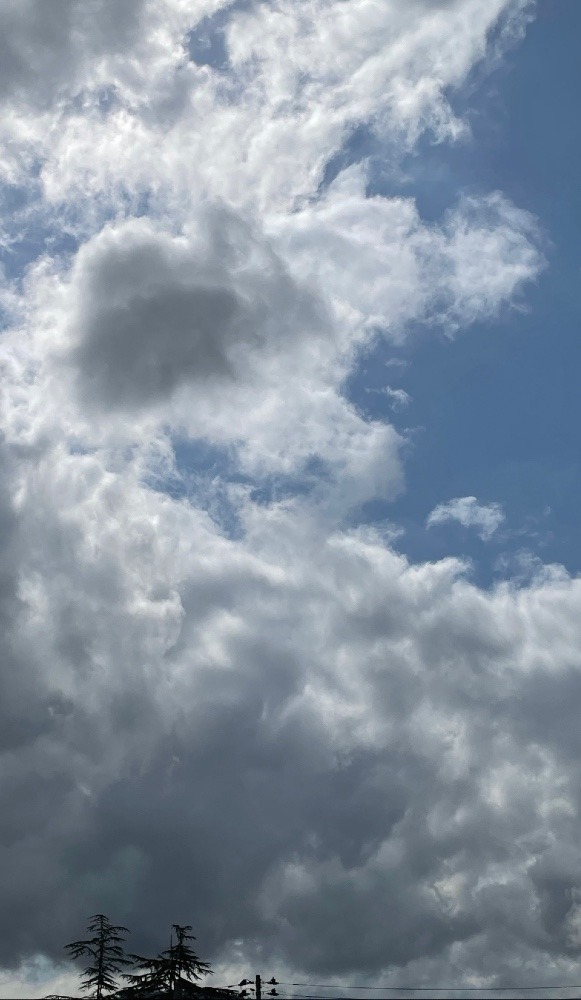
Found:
68,207 -> 327,409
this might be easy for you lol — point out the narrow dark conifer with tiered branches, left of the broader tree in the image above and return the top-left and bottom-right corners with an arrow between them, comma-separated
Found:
65,913 -> 131,1000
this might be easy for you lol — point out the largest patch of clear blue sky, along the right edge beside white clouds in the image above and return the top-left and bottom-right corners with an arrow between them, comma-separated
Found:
340,0 -> 581,580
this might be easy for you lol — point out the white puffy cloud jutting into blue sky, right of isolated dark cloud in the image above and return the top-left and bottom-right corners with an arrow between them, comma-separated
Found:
271,164 -> 542,343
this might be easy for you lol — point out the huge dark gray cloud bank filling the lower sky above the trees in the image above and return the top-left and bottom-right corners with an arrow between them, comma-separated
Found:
0,456 -> 580,981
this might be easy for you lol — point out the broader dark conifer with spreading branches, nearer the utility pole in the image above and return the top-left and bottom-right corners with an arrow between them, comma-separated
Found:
124,924 -> 213,996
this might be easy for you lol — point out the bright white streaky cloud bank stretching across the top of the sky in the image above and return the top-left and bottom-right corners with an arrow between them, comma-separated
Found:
2,0 -> 529,217
